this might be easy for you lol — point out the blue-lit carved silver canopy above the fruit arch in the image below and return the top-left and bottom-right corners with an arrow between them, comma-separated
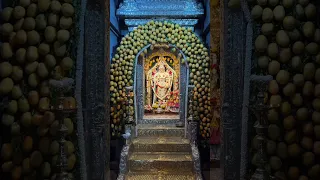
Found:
117,0 -> 204,31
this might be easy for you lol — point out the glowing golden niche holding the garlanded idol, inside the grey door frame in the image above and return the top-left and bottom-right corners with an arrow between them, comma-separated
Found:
143,48 -> 181,118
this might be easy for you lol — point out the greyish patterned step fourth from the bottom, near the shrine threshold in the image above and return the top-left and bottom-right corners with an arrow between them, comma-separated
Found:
136,124 -> 184,137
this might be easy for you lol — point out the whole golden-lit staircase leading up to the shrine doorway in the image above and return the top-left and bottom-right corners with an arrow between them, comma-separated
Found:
120,120 -> 199,180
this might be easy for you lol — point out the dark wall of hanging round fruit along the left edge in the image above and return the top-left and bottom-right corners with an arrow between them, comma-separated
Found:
0,0 -> 76,179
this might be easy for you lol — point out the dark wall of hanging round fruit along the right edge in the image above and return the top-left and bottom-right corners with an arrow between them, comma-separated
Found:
251,0 -> 320,179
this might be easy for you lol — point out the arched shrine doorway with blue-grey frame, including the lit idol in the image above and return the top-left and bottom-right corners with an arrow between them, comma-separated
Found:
135,44 -> 187,124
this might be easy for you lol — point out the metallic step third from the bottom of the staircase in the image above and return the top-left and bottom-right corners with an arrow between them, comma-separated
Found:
133,137 -> 191,152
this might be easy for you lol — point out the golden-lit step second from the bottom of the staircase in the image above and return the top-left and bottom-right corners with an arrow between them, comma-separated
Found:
129,152 -> 193,172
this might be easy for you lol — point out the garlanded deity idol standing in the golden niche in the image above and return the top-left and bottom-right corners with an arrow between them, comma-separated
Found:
153,62 -> 172,103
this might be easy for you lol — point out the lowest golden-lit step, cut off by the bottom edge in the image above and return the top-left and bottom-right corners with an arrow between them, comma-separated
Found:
125,171 -> 196,180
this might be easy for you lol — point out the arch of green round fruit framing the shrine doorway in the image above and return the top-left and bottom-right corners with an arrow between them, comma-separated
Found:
110,21 -> 212,138
